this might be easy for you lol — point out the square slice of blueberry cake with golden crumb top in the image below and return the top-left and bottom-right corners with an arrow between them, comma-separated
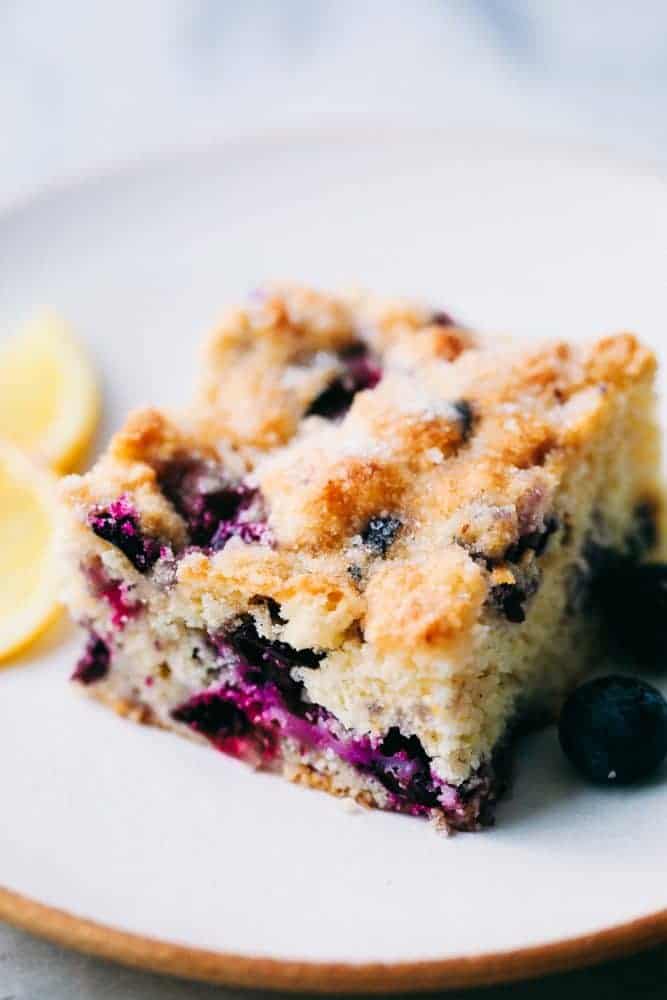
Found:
64,287 -> 659,830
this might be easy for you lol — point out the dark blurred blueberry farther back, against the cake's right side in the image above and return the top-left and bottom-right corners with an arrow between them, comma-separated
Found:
596,563 -> 667,670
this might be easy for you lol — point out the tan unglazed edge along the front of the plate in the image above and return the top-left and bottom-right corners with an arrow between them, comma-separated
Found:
0,887 -> 667,993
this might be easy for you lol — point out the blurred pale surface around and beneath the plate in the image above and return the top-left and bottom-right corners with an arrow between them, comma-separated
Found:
0,0 -> 667,1000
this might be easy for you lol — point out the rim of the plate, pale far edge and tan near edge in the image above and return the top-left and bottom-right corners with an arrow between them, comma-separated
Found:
0,123 -> 667,994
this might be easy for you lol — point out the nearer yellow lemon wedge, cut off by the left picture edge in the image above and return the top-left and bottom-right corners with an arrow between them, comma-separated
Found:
0,440 -> 59,660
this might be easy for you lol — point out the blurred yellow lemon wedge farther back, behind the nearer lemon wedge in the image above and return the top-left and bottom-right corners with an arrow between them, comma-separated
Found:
0,312 -> 100,474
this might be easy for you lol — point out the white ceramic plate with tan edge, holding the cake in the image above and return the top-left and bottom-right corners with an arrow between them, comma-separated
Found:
0,129 -> 667,989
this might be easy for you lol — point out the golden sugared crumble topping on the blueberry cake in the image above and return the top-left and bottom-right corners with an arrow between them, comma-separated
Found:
65,288 -> 655,644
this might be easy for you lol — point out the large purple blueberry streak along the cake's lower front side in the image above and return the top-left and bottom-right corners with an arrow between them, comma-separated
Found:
172,620 -> 491,829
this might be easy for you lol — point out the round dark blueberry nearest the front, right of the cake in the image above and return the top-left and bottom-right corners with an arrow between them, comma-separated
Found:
558,674 -> 667,785
